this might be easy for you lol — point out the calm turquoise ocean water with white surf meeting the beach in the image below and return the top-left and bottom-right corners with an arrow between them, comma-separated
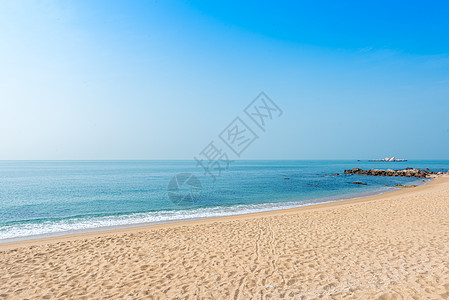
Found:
0,160 -> 449,242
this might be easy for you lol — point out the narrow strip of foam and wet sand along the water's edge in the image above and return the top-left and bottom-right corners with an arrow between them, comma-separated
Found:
0,177 -> 441,251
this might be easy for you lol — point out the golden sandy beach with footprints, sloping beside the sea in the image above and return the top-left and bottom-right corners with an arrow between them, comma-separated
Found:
0,176 -> 449,299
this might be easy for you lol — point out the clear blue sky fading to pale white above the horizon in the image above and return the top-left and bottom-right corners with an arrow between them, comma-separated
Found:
0,0 -> 449,159
